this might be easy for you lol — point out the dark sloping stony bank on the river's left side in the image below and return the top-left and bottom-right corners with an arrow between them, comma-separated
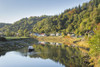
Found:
0,37 -> 37,51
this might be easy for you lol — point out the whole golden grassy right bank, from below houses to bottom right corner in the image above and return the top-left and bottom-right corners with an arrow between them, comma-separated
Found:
37,36 -> 100,67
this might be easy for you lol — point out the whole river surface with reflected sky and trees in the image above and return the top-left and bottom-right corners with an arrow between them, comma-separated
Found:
0,42 -> 89,67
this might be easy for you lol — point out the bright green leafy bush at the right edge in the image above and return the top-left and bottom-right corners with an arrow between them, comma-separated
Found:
89,29 -> 100,56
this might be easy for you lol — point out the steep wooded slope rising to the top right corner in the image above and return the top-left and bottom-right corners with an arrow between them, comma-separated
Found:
33,0 -> 100,35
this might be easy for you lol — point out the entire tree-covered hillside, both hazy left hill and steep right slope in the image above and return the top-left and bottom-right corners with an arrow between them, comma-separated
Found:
1,0 -> 100,35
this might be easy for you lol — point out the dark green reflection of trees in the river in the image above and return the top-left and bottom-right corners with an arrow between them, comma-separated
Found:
31,45 -> 87,67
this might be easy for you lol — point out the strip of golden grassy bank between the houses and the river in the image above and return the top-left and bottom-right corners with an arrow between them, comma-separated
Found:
37,36 -> 89,48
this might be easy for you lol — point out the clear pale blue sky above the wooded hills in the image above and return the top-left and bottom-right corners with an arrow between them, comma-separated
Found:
0,0 -> 90,23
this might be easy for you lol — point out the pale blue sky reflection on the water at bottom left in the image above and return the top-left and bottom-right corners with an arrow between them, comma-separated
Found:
0,51 -> 64,67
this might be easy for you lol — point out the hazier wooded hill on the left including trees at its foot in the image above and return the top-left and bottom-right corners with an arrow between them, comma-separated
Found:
0,15 -> 50,36
